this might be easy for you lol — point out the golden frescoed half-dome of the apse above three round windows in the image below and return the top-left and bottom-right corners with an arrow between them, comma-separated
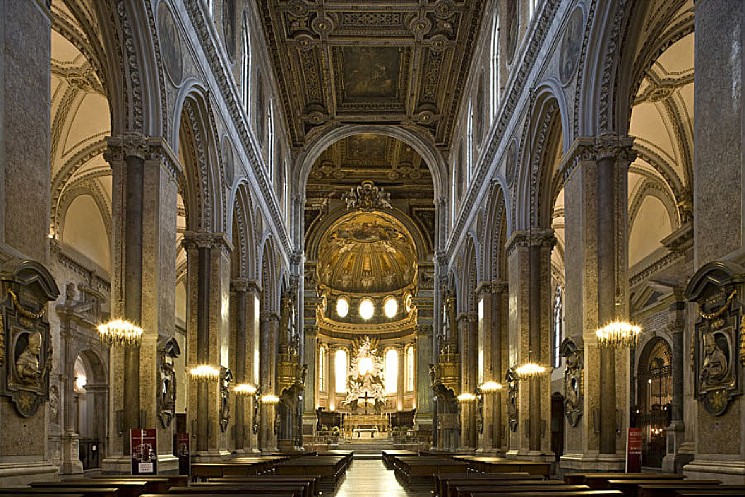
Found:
318,211 -> 417,294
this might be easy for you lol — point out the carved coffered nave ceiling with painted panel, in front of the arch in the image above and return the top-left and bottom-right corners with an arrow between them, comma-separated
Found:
259,0 -> 485,146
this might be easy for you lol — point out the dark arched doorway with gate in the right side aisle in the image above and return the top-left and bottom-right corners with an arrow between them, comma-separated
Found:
635,337 -> 673,468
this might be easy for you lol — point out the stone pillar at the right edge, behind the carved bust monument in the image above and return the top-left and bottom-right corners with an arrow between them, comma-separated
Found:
683,0 -> 745,484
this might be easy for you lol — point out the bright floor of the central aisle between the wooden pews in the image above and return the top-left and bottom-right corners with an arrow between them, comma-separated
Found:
334,459 -> 434,497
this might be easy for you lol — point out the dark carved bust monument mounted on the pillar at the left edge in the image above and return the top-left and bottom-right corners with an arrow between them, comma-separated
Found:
0,259 -> 59,417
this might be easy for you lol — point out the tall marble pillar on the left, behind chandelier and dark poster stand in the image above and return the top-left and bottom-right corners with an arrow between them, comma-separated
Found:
102,133 -> 178,472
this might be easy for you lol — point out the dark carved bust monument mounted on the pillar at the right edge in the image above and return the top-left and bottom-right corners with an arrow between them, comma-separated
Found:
686,261 -> 745,416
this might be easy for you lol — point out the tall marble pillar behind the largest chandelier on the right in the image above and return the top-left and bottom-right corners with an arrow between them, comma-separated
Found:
561,135 -> 634,471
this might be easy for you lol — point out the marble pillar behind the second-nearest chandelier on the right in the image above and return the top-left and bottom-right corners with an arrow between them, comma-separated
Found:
507,228 -> 555,460
